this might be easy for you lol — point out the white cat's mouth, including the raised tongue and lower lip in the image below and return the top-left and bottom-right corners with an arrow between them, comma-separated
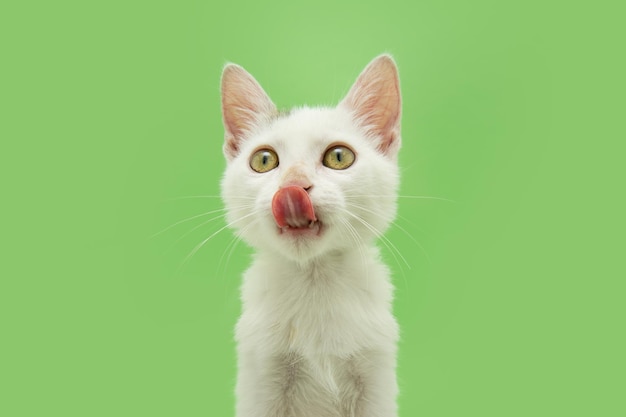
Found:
272,185 -> 322,236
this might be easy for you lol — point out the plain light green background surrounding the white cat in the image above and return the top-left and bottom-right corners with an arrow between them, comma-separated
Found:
0,0 -> 626,417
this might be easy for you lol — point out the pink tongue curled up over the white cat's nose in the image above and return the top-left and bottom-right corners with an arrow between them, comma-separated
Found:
272,185 -> 317,228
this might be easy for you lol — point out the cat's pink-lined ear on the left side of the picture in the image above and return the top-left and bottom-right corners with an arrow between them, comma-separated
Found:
222,64 -> 277,159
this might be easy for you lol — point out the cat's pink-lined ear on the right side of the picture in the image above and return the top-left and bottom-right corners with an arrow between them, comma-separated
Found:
339,55 -> 401,156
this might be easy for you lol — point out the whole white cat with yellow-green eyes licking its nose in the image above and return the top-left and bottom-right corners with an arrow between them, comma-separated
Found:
221,55 -> 401,417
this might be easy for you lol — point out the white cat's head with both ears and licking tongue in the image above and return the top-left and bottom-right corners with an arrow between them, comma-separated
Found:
222,55 -> 401,261
